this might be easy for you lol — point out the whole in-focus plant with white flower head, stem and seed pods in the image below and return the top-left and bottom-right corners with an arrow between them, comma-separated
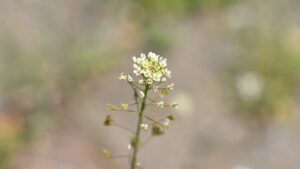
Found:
102,52 -> 178,169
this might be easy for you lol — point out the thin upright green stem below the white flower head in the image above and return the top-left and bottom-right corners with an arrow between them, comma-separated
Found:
131,84 -> 149,169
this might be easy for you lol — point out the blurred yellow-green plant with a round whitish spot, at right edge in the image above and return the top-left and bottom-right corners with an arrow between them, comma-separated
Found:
225,32 -> 300,124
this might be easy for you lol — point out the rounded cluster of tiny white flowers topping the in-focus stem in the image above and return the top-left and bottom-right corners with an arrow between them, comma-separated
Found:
133,52 -> 171,85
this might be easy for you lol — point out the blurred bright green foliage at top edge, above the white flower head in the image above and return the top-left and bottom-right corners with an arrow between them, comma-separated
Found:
122,0 -> 240,52
